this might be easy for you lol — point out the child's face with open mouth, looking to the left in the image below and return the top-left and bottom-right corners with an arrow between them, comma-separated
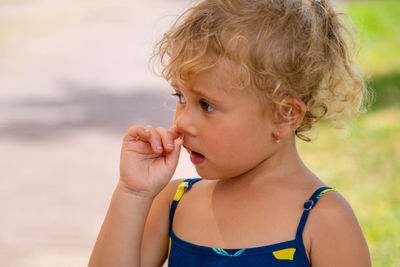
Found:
171,63 -> 275,179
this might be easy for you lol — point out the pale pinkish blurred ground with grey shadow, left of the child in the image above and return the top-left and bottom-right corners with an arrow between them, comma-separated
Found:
0,0 -> 196,267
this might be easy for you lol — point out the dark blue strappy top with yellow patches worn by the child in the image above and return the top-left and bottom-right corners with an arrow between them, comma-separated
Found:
168,179 -> 334,267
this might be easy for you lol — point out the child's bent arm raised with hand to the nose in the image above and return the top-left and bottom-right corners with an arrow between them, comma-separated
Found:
89,126 -> 182,267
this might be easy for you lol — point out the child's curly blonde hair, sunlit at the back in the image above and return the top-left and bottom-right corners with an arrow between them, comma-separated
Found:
154,0 -> 368,141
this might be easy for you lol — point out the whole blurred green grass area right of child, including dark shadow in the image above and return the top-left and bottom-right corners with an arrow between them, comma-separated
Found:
299,0 -> 400,267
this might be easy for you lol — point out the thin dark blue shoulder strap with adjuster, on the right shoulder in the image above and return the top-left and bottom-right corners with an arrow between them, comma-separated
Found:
296,187 -> 335,258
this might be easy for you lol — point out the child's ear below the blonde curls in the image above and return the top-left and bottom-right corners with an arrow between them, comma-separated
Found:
275,98 -> 307,138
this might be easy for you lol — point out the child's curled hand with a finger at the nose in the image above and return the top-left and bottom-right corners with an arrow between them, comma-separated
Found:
120,126 -> 182,198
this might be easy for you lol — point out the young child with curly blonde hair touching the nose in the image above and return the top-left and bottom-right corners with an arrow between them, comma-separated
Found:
89,0 -> 371,267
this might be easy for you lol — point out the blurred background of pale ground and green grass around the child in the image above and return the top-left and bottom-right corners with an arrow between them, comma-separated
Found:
0,0 -> 400,267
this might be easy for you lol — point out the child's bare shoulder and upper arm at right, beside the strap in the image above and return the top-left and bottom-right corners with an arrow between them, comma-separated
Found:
304,191 -> 371,267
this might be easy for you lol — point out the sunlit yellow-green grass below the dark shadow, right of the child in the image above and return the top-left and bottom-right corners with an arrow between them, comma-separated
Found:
299,108 -> 400,267
